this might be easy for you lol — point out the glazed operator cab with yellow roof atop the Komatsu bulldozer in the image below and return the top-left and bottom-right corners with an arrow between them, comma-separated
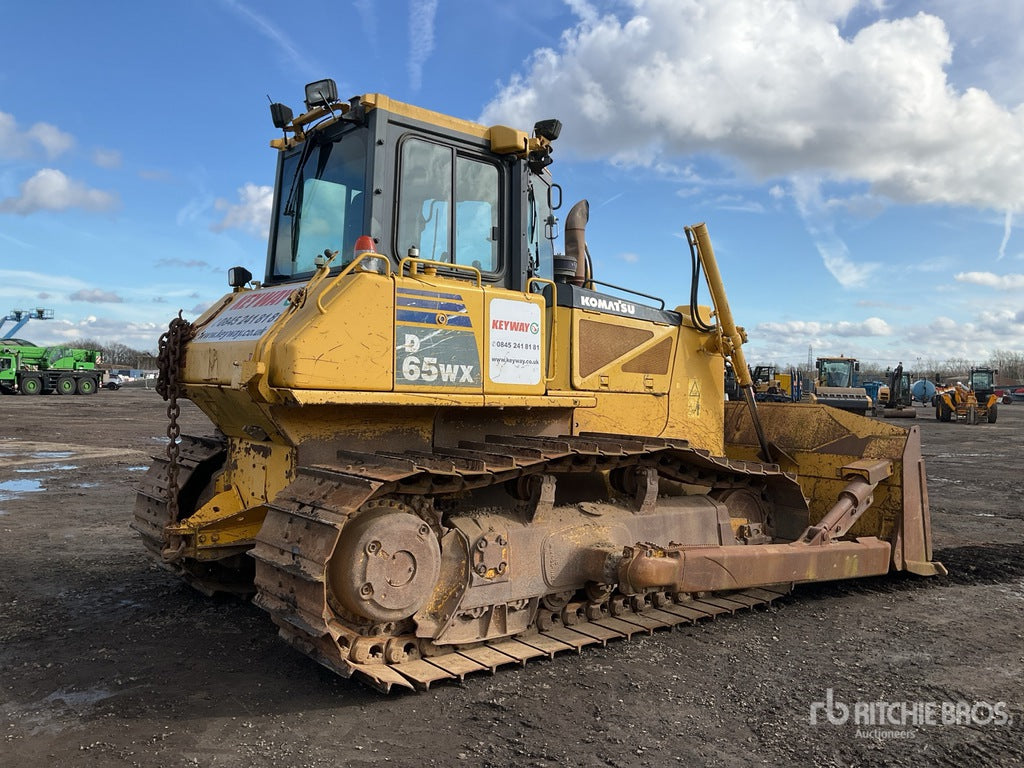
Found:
264,94 -> 557,290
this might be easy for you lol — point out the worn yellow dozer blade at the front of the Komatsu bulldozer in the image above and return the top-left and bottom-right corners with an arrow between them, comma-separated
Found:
725,402 -> 946,575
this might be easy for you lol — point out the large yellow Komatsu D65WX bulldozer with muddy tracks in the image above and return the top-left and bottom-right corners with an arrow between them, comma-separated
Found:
134,80 -> 943,690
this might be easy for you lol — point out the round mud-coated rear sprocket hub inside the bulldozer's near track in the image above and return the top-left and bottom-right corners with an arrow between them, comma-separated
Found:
327,502 -> 441,623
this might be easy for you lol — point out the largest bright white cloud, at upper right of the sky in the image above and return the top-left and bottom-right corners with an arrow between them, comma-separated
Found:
481,0 -> 1024,211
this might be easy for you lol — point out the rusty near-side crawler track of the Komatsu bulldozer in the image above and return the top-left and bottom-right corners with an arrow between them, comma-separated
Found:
250,433 -> 806,692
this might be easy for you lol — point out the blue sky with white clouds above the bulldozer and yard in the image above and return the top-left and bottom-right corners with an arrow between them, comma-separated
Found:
0,0 -> 1024,369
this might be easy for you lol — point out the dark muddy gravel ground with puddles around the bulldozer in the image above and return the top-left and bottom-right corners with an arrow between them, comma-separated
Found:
0,388 -> 1024,768
